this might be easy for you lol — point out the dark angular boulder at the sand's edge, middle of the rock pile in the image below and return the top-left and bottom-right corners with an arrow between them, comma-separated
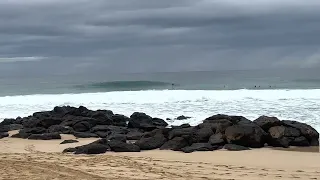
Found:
135,130 -> 167,150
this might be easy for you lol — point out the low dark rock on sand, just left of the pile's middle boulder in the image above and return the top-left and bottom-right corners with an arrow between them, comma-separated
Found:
108,140 -> 140,152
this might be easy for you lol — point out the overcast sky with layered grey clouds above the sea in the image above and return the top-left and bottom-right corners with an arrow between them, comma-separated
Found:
0,0 -> 320,76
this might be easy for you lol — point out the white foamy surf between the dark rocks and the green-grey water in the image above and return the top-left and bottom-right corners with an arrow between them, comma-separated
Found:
0,89 -> 320,131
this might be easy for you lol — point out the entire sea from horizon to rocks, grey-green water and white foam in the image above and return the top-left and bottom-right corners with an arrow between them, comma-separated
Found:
0,69 -> 320,131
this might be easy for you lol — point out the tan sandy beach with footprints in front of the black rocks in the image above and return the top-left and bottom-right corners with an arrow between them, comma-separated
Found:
0,131 -> 320,180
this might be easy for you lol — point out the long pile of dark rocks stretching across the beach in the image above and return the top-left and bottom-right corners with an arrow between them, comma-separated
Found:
0,106 -> 319,154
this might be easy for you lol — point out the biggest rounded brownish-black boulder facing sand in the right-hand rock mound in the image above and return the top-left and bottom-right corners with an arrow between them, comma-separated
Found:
225,124 -> 267,148
